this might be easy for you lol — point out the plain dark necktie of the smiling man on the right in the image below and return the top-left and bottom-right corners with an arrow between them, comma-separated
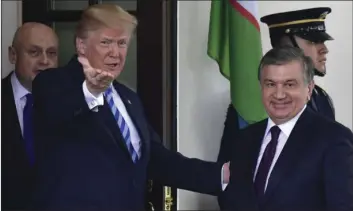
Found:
255,126 -> 281,198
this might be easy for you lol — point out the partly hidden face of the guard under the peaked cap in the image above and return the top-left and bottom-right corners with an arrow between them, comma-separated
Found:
295,36 -> 328,74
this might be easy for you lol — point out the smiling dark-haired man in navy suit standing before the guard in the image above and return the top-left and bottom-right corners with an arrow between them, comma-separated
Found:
222,47 -> 353,211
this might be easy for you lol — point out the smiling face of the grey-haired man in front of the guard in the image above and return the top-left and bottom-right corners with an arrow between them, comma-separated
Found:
260,60 -> 314,124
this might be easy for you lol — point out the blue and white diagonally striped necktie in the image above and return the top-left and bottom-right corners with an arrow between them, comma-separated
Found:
105,87 -> 138,163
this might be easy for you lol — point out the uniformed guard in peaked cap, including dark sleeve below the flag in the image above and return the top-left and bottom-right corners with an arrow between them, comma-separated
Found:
217,7 -> 335,175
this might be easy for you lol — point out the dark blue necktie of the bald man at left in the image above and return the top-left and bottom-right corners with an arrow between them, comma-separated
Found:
23,94 -> 34,166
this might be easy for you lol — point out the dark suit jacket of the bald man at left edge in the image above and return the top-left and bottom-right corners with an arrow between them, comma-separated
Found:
1,72 -> 33,210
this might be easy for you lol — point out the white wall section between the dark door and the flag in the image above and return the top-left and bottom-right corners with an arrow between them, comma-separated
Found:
177,1 -> 230,210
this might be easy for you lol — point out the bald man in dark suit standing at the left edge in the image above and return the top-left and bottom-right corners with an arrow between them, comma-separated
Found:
1,22 -> 58,210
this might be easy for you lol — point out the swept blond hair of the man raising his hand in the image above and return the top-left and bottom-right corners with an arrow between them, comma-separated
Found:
75,4 -> 137,39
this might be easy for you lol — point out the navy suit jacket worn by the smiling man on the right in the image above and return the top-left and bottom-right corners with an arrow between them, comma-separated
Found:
221,107 -> 353,211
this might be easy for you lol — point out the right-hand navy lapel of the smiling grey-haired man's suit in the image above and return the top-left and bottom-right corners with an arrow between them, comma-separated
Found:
262,108 -> 311,203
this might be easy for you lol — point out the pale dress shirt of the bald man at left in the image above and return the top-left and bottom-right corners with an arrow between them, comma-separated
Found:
11,72 -> 30,135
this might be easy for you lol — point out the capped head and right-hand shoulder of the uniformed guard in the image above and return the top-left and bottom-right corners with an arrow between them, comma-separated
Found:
261,7 -> 335,120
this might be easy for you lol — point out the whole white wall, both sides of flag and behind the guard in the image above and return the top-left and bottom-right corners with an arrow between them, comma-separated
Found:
177,1 -> 353,210
